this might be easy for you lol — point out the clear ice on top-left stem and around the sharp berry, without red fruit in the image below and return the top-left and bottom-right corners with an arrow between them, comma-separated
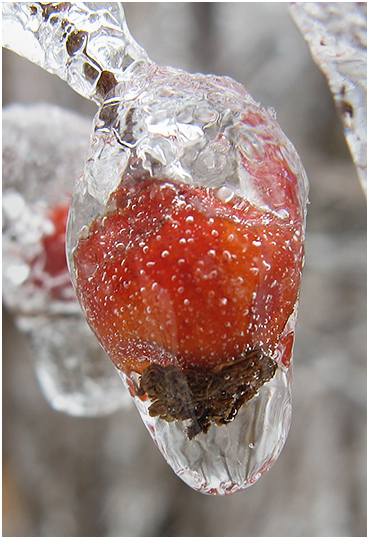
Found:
3,3 -> 308,494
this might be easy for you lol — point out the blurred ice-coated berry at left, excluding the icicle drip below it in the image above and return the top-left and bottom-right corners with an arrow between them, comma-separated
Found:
2,105 -> 88,315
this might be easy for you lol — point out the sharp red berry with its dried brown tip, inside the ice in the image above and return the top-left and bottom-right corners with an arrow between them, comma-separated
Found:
74,107 -> 305,439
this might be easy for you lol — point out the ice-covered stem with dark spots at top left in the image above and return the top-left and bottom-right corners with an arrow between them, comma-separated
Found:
2,2 -> 147,103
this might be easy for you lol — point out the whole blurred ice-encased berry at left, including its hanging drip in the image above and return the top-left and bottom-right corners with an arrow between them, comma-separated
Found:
2,105 -> 129,416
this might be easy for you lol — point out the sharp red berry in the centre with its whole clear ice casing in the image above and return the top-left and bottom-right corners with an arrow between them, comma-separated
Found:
68,64 -> 308,494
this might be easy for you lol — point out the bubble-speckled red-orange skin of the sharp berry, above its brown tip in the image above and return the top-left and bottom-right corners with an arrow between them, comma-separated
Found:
74,177 -> 303,374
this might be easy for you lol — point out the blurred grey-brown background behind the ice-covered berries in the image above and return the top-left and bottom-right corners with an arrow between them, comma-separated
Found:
3,2 -> 366,537
